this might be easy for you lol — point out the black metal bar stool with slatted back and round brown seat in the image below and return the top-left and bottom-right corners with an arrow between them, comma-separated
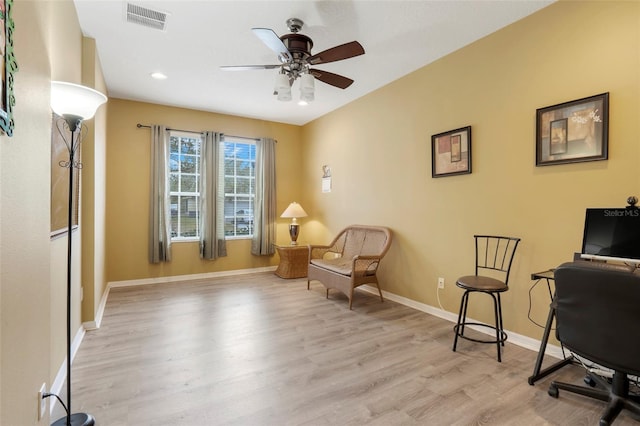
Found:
453,235 -> 520,362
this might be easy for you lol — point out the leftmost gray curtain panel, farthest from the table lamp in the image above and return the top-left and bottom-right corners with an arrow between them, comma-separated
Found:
149,124 -> 171,263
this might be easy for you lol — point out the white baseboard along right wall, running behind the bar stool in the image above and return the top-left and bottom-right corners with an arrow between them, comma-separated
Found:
359,285 -> 564,359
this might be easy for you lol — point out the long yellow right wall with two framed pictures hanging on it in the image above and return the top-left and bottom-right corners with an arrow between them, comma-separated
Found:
301,1 -> 640,339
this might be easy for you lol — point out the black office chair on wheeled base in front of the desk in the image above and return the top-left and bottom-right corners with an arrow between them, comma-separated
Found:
549,261 -> 640,425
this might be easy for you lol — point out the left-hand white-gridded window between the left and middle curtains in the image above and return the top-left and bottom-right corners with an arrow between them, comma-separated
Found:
169,130 -> 202,240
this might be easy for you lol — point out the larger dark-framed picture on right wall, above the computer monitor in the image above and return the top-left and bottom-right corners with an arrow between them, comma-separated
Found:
536,93 -> 609,166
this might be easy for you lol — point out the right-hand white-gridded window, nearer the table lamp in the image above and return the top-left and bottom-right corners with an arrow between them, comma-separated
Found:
222,136 -> 256,239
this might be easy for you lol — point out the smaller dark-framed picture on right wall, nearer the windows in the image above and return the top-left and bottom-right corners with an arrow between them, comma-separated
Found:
431,126 -> 471,177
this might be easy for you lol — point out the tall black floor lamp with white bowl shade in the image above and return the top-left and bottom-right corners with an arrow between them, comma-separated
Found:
51,81 -> 107,426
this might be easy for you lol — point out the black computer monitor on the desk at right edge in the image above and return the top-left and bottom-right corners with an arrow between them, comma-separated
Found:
580,208 -> 640,264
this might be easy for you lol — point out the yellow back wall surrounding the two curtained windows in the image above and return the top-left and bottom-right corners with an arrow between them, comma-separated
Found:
106,99 -> 303,281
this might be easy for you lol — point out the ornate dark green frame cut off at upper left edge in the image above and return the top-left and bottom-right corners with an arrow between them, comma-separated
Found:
0,0 -> 18,136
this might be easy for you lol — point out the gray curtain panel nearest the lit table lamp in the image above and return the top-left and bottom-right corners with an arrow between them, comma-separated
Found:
251,138 -> 277,256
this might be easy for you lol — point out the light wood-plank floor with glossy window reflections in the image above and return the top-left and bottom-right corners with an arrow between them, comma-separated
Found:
52,273 -> 638,426
